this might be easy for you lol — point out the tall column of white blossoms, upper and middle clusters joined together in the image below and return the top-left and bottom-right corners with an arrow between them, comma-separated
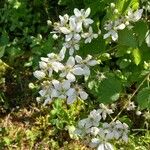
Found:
33,8 -> 98,105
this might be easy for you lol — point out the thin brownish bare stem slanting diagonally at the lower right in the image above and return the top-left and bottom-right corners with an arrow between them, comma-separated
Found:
111,73 -> 150,122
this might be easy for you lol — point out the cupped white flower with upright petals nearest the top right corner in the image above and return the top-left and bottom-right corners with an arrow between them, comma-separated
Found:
126,9 -> 143,22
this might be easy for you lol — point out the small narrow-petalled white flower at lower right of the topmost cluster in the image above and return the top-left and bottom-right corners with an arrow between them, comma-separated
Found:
82,27 -> 98,44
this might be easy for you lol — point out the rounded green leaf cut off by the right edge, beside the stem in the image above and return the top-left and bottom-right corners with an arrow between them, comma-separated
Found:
137,87 -> 150,109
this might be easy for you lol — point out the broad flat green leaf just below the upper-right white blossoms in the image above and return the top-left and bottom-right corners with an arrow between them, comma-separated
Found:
118,29 -> 138,48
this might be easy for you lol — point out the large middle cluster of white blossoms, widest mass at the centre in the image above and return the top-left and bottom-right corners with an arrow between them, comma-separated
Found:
33,47 -> 97,105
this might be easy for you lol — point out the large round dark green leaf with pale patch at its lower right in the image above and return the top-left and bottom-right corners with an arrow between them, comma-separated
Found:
98,77 -> 122,103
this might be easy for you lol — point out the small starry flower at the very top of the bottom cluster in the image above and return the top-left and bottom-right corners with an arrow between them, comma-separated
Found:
99,103 -> 113,120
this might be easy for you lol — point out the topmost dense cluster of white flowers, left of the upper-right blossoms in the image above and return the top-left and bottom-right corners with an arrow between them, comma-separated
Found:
51,8 -> 100,55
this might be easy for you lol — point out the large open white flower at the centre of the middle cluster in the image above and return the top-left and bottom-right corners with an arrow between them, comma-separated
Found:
60,56 -> 83,82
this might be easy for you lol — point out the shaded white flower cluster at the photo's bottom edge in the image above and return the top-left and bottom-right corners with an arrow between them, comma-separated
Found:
74,104 -> 129,150
